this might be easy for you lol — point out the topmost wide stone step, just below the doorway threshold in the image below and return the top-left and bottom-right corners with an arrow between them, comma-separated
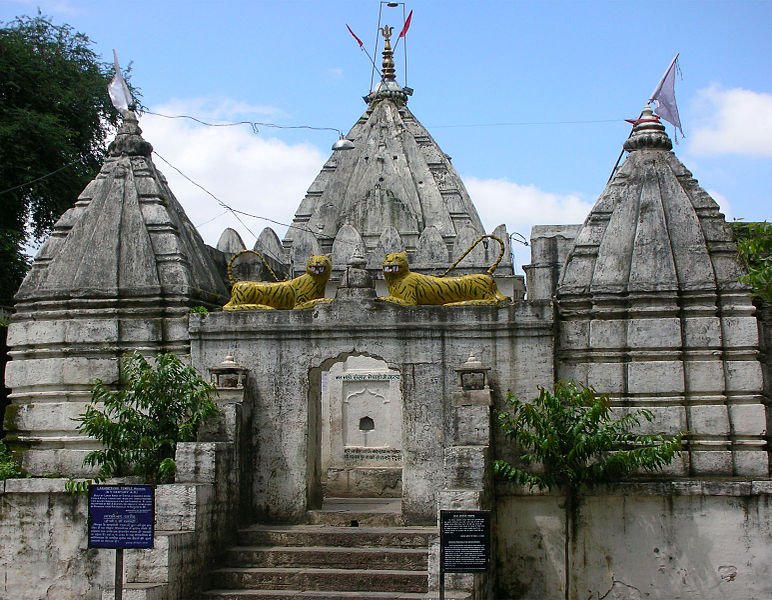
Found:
239,525 -> 439,549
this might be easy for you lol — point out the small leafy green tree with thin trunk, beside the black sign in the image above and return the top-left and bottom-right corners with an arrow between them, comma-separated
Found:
494,382 -> 682,598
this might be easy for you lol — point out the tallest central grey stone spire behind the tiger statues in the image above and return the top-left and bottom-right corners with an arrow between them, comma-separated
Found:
256,26 -> 512,286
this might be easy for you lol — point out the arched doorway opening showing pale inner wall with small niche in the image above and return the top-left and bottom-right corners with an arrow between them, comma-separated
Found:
319,355 -> 402,498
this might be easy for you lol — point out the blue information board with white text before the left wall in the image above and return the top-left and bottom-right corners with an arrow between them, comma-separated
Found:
88,485 -> 155,548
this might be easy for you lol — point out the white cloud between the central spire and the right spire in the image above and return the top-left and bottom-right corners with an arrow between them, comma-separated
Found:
464,177 -> 593,266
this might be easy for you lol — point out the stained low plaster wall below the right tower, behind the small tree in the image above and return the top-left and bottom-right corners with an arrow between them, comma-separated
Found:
495,481 -> 772,600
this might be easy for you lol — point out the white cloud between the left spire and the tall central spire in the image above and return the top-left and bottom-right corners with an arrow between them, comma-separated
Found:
140,100 -> 326,248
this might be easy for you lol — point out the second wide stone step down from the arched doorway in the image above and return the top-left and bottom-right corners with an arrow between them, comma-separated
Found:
225,546 -> 428,571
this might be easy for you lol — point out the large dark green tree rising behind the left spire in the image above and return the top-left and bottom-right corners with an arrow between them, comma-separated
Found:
0,16 -> 133,305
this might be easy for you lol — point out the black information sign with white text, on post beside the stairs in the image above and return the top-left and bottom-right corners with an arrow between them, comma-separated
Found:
440,510 -> 491,600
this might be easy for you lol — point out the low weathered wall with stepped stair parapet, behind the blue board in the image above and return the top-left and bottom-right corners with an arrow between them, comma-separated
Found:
0,390 -> 246,600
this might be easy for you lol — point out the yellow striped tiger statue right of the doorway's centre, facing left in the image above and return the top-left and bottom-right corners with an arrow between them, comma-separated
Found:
378,251 -> 510,306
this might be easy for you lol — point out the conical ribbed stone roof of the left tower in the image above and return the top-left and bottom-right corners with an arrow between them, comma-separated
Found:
17,111 -> 227,305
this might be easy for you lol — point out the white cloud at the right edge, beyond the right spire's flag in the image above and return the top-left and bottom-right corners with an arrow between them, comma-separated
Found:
687,86 -> 772,157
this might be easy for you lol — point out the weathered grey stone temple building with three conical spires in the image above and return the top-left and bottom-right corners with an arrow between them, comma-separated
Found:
0,31 -> 772,599
